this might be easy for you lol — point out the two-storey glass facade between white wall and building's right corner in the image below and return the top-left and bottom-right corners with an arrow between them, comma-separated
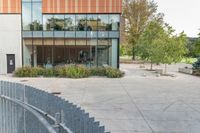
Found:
22,0 -> 120,68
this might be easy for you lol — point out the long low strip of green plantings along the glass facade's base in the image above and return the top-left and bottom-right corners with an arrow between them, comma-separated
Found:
14,65 -> 124,78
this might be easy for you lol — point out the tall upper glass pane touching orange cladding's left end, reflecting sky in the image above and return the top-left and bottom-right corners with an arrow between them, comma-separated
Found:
32,3 -> 42,30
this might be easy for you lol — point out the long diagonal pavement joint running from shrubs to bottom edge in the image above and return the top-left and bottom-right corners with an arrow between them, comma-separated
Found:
119,81 -> 155,133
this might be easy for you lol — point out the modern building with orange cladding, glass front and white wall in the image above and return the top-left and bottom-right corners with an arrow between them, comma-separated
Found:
0,0 -> 122,74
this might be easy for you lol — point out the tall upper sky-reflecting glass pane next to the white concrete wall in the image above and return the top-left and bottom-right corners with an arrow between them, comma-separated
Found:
22,3 -> 32,30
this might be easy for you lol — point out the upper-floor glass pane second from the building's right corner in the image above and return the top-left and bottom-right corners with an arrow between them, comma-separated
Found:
98,14 -> 109,31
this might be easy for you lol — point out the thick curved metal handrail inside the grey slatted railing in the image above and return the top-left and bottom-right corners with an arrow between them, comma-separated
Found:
0,95 -> 57,133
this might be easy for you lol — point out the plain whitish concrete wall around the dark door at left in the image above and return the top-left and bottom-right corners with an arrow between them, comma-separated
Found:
0,14 -> 22,74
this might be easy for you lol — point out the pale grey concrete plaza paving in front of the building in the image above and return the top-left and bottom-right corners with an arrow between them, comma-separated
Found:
0,64 -> 200,133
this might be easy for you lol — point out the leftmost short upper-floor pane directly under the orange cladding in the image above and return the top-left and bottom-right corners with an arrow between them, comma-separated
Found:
43,15 -> 54,31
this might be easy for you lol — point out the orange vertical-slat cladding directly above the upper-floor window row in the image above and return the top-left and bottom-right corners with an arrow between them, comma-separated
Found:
43,0 -> 122,14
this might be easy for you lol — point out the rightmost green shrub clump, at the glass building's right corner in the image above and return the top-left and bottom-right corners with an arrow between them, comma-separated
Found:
106,67 -> 124,78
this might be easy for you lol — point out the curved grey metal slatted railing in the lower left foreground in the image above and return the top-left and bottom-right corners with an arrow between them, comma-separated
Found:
0,81 -> 109,133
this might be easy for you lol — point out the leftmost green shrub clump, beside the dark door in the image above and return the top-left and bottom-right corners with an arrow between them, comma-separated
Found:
14,66 -> 44,77
